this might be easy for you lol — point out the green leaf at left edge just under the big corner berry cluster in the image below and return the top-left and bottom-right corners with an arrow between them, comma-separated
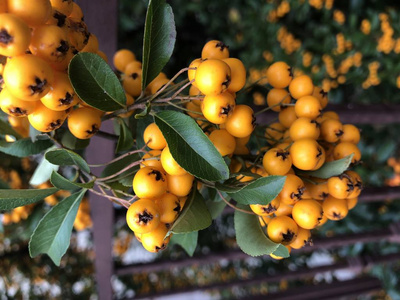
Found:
0,138 -> 54,157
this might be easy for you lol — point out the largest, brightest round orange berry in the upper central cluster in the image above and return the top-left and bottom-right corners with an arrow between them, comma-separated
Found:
195,59 -> 231,95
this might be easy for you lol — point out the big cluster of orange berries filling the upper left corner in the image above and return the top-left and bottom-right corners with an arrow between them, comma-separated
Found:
0,0 -> 106,139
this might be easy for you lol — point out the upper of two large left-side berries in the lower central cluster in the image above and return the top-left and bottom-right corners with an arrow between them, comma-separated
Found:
133,167 -> 168,198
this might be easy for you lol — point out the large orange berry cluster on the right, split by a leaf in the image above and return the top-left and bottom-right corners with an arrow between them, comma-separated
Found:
251,62 -> 362,259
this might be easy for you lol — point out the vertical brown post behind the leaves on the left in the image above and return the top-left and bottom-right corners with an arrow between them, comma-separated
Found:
76,0 -> 118,300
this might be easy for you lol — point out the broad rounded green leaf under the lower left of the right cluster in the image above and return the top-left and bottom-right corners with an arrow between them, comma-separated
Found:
234,210 -> 289,257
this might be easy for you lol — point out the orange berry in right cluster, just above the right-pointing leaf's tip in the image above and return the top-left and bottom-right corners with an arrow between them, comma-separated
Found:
263,148 -> 292,175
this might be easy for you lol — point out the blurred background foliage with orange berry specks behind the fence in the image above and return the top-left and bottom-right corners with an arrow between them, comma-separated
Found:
0,0 -> 400,299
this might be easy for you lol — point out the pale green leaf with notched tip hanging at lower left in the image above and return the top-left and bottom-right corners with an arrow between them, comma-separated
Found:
29,189 -> 86,266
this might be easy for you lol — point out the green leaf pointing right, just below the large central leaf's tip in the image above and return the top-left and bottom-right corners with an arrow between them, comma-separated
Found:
228,176 -> 286,205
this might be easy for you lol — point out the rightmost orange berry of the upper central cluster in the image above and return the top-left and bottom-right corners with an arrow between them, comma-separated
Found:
225,104 -> 256,138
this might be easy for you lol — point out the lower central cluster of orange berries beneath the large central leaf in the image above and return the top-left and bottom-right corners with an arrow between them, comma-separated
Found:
126,123 -> 194,252
